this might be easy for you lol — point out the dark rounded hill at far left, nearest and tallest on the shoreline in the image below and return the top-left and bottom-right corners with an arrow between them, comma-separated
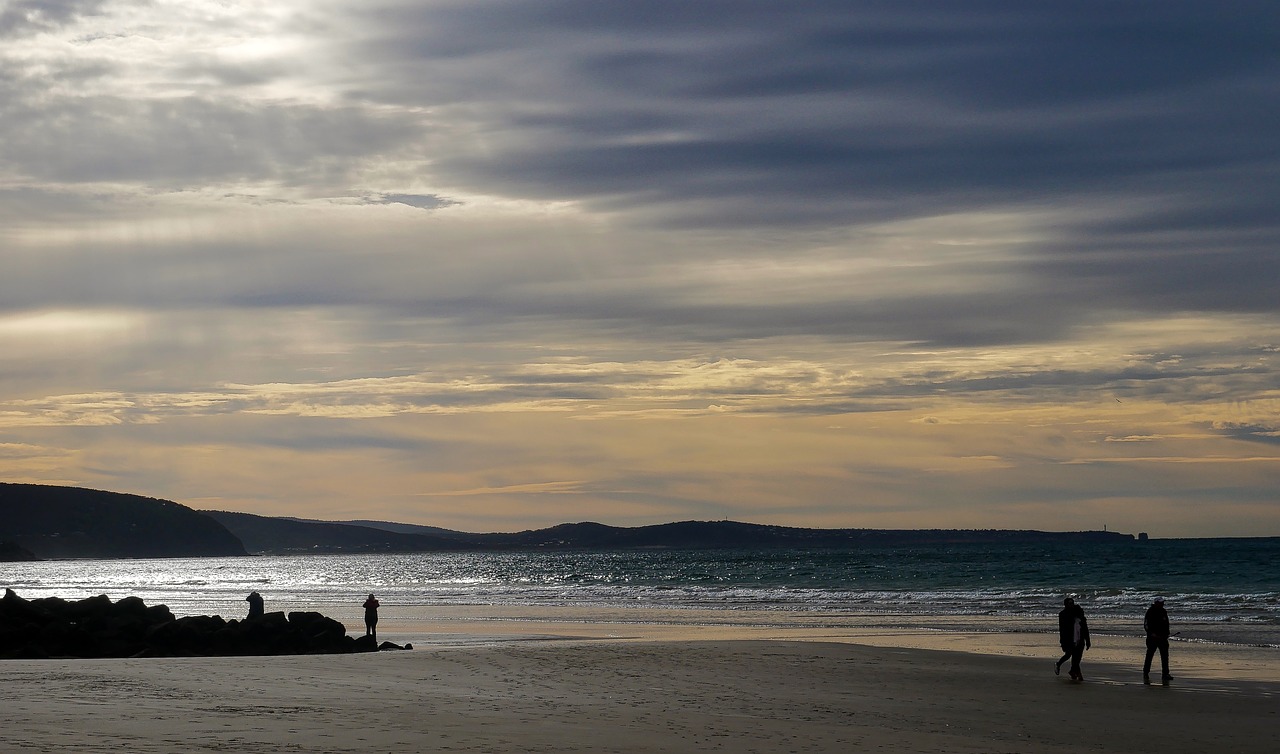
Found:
0,483 -> 247,558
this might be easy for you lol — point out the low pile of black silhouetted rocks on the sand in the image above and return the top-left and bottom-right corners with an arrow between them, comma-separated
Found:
0,589 -> 412,659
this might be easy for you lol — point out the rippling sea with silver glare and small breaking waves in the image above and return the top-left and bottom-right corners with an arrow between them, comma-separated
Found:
0,538 -> 1280,648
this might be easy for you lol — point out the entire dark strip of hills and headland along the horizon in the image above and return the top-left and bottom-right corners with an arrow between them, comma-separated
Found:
0,483 -> 1134,561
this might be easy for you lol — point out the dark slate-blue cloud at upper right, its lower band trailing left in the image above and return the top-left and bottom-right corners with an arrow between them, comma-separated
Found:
317,0 -> 1280,346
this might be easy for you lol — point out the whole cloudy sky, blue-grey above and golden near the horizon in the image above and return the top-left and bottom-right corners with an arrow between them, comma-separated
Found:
0,0 -> 1280,536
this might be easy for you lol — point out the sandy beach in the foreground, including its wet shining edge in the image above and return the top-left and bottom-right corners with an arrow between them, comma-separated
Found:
0,608 -> 1280,754
